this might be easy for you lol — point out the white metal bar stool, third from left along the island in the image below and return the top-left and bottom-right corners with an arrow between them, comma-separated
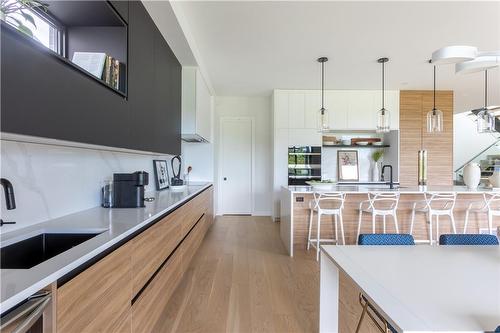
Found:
410,192 -> 457,244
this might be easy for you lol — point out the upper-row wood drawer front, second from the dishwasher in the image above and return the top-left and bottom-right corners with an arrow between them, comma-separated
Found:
131,208 -> 182,295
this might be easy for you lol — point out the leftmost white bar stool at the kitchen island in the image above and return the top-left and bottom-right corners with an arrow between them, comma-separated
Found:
307,192 -> 345,260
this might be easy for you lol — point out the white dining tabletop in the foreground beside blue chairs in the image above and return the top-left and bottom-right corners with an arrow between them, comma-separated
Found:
322,245 -> 500,332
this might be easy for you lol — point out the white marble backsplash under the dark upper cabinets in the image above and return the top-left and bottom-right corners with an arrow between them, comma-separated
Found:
0,140 -> 172,232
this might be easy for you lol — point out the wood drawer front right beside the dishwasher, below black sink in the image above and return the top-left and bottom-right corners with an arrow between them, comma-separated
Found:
56,244 -> 132,333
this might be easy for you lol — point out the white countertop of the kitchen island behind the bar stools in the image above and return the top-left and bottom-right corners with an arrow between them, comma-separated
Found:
283,184 -> 494,194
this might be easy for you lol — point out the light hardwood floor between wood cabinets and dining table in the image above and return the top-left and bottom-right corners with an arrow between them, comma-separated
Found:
154,216 -> 319,332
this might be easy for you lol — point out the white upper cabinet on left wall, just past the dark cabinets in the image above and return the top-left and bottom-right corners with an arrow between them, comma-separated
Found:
181,67 -> 212,142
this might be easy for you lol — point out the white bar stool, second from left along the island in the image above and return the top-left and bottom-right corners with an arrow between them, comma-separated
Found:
356,192 -> 399,244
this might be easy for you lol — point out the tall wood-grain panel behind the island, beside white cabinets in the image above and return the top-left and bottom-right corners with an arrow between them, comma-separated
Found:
399,90 -> 453,186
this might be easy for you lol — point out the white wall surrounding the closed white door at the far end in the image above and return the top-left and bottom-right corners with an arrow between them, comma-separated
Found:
214,96 -> 273,216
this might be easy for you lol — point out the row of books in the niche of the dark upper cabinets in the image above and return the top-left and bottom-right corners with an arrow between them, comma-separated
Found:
72,52 -> 126,92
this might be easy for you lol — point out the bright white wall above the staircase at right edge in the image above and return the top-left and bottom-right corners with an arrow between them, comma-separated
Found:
453,112 -> 498,170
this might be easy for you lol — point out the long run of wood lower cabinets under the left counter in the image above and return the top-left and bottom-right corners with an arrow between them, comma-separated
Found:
57,187 -> 213,333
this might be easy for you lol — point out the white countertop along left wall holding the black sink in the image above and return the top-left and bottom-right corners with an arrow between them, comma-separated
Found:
0,183 -> 211,313
